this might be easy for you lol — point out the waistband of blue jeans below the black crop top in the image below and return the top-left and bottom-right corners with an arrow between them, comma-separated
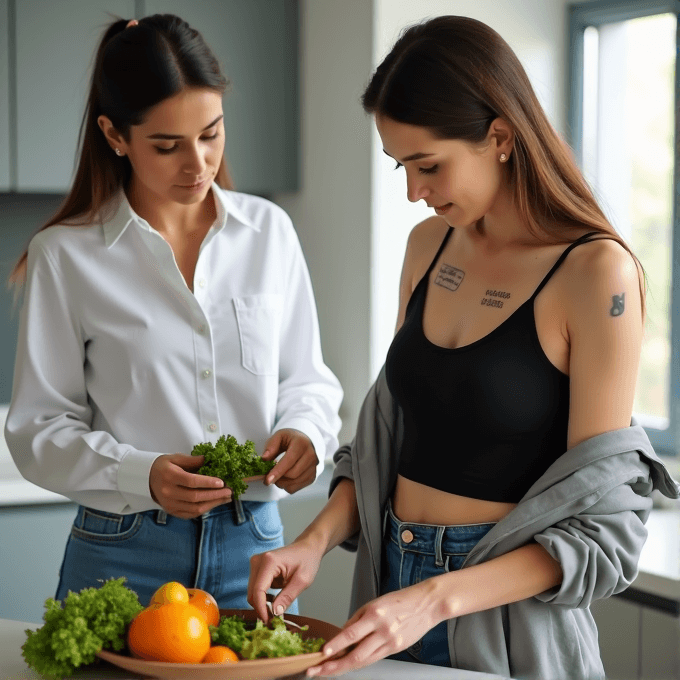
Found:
385,501 -> 496,557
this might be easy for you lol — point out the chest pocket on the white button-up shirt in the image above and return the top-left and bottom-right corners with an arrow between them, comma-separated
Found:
233,293 -> 283,375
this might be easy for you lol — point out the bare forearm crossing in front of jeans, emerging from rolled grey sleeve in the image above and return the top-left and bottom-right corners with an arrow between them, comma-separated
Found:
428,543 -> 562,621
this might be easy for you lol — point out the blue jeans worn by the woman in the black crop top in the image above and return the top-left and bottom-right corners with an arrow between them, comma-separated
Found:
380,502 -> 494,668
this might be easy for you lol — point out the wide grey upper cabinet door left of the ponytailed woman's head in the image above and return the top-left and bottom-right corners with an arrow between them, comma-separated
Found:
16,0 -> 135,193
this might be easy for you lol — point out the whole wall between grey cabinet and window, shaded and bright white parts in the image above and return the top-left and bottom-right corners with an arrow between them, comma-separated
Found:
274,0 -> 568,441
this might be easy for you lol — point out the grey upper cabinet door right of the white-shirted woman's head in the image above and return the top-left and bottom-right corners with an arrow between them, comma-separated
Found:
144,0 -> 299,194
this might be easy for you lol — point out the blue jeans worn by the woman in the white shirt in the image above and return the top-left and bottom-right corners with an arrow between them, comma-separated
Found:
56,499 -> 298,614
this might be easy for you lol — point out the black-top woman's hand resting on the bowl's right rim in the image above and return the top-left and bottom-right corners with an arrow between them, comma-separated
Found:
307,581 -> 444,677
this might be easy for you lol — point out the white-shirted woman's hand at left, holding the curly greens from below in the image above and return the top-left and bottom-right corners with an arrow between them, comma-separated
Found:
149,453 -> 231,519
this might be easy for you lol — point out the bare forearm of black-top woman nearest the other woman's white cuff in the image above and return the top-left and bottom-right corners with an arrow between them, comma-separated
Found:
294,478 -> 360,555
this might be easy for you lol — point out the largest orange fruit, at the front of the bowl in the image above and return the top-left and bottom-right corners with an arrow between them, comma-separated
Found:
127,602 -> 211,663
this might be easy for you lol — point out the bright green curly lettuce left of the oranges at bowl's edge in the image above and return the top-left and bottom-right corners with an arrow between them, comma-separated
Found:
21,577 -> 143,678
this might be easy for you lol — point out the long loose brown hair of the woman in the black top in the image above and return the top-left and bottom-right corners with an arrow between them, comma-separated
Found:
362,16 -> 645,313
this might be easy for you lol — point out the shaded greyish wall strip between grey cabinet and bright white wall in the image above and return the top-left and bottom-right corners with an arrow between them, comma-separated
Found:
273,0 -> 373,442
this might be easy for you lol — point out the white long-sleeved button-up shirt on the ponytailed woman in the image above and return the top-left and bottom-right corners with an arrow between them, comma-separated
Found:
5,184 -> 342,514
